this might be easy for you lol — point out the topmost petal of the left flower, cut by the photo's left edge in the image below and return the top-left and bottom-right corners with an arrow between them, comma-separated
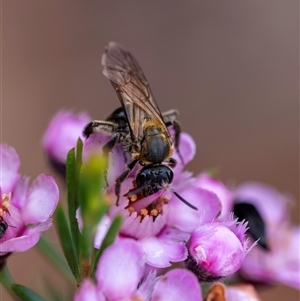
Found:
0,144 -> 20,193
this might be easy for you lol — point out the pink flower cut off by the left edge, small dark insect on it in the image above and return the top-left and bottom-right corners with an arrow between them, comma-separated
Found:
0,144 -> 59,256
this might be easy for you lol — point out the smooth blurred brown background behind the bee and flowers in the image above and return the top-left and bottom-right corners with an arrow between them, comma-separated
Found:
0,0 -> 299,301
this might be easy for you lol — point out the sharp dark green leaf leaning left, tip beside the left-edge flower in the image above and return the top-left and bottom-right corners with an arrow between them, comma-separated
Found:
55,206 -> 79,281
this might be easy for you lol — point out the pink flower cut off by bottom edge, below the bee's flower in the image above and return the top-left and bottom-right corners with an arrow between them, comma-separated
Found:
74,239 -> 202,301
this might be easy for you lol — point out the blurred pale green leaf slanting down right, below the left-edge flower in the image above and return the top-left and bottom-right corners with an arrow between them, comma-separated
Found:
37,236 -> 74,284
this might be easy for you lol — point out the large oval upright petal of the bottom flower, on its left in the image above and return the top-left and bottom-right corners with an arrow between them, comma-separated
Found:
96,239 -> 145,300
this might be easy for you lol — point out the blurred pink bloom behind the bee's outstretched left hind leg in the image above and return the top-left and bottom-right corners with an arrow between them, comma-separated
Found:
42,110 -> 91,167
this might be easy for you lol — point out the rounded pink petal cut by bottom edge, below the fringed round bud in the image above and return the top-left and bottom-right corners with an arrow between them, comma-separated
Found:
151,269 -> 202,301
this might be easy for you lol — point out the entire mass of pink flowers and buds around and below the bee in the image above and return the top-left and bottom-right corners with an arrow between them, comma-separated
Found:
0,111 -> 300,301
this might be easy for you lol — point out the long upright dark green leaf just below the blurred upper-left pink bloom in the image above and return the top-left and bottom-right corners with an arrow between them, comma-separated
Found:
66,148 -> 79,254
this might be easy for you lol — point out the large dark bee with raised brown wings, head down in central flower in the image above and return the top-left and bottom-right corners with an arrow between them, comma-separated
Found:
84,42 -> 197,210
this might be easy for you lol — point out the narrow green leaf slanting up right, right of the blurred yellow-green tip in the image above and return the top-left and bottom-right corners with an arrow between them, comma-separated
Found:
92,215 -> 122,275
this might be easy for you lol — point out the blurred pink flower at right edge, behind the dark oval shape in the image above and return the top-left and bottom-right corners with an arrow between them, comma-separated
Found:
234,182 -> 300,290
